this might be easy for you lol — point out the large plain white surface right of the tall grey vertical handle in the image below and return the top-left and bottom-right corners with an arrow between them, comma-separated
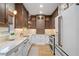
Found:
62,6 -> 79,56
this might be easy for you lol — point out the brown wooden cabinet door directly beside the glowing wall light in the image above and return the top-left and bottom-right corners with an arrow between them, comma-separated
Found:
15,4 -> 23,28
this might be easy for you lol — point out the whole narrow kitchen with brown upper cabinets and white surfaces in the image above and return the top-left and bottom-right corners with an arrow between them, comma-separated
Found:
0,3 -> 79,56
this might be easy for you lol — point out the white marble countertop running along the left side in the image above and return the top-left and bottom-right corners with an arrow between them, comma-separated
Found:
0,37 -> 28,55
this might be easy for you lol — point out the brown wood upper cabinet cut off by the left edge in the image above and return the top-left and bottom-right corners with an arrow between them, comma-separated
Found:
0,3 -> 7,27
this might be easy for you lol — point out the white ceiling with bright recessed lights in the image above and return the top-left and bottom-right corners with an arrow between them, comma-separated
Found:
24,3 -> 58,15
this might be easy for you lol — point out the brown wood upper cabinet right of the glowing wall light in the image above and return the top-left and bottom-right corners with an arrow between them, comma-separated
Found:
15,3 -> 28,28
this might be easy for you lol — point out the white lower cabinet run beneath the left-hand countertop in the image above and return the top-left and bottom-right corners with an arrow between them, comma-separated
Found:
10,40 -> 31,56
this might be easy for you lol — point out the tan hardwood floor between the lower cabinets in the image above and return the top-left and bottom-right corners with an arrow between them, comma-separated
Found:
28,44 -> 53,56
